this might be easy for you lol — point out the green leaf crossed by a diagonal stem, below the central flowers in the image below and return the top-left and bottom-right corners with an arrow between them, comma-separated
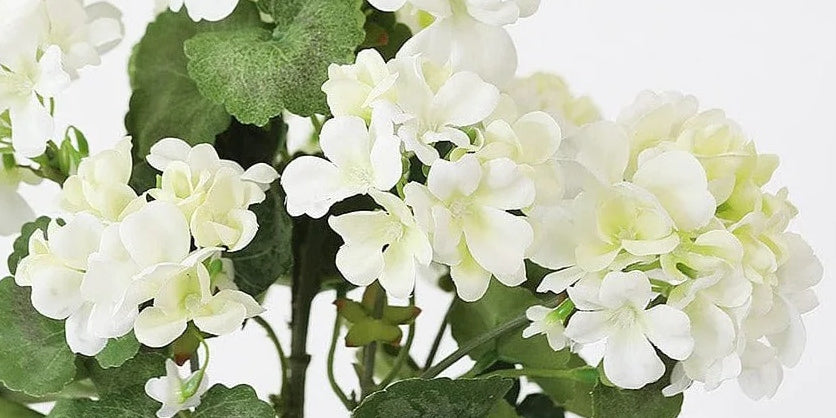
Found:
450,281 -> 570,369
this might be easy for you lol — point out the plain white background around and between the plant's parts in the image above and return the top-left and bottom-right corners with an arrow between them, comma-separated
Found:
0,0 -> 836,418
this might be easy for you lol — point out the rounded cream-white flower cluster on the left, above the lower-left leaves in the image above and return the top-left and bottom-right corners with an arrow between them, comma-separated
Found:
15,138 -> 278,355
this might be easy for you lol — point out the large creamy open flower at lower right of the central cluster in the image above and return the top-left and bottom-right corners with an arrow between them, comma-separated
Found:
404,154 -> 534,301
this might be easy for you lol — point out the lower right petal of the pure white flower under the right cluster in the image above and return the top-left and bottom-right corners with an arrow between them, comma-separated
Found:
645,305 -> 694,360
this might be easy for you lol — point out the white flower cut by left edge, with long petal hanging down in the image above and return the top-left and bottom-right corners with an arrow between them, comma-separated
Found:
0,44 -> 70,158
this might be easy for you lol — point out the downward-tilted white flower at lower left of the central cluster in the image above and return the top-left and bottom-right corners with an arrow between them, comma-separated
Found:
328,192 -> 432,298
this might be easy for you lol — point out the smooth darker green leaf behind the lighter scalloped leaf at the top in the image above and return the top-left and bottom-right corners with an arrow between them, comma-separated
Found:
125,6 -> 261,163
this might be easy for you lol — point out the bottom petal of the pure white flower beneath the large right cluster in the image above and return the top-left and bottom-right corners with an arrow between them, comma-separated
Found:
604,328 -> 665,389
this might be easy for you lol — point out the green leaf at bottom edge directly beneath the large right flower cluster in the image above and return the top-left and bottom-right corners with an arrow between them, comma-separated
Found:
592,376 -> 683,418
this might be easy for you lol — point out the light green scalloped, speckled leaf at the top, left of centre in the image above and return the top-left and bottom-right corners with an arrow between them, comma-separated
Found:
185,0 -> 365,126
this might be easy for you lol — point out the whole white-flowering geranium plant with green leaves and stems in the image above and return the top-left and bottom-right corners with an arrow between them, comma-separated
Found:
0,0 -> 823,418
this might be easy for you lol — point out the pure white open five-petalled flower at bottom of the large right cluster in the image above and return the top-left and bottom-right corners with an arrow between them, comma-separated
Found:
566,271 -> 694,389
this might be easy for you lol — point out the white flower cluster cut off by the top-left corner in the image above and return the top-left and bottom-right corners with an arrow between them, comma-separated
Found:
0,0 -> 123,235
